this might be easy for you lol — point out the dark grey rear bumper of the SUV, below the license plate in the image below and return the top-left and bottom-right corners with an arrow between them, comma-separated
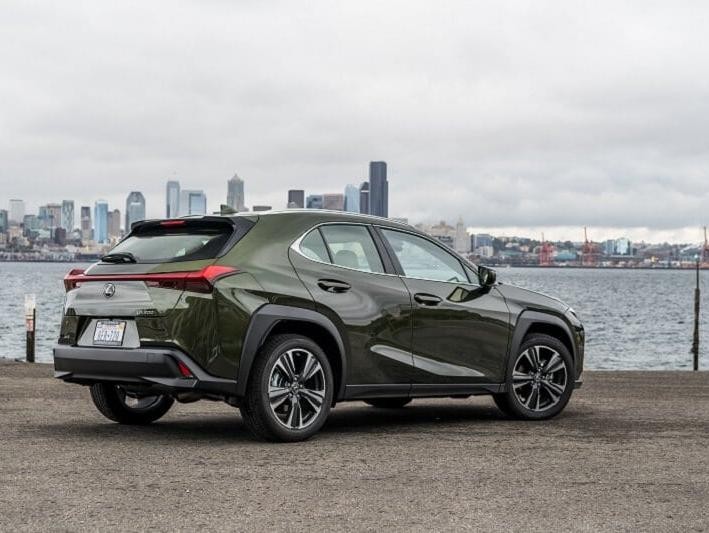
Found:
54,345 -> 236,397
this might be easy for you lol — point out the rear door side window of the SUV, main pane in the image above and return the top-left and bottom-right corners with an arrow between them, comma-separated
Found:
320,224 -> 384,272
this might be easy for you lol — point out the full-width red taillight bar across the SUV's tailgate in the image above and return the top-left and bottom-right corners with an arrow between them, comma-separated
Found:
64,265 -> 238,293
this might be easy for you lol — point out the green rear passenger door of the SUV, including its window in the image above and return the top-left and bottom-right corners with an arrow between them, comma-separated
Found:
290,223 -> 413,397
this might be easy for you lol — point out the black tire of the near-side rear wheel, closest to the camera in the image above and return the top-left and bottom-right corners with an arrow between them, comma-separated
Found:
240,335 -> 335,442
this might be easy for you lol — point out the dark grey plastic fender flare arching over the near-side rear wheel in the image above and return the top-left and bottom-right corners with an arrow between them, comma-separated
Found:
236,304 -> 347,399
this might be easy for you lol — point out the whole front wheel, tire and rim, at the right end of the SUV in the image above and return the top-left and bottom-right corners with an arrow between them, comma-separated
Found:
493,334 -> 574,420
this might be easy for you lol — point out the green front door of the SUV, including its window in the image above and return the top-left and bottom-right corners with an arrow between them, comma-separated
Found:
378,227 -> 511,387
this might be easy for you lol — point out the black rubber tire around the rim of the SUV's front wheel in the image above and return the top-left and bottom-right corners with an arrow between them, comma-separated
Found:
493,333 -> 575,420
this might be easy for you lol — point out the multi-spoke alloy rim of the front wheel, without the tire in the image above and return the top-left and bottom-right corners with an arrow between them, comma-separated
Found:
512,345 -> 568,412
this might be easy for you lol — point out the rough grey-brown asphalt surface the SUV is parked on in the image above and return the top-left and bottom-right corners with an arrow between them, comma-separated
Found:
0,363 -> 709,531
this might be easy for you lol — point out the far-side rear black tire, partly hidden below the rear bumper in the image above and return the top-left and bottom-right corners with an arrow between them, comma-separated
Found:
91,383 -> 175,425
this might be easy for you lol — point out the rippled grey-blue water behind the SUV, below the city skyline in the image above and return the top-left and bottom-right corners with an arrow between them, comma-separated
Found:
0,263 -> 709,369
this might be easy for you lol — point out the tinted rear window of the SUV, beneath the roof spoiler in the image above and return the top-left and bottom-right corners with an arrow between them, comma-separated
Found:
109,218 -> 253,263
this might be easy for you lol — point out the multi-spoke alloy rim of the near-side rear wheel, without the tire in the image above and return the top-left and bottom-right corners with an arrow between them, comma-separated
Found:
268,348 -> 325,429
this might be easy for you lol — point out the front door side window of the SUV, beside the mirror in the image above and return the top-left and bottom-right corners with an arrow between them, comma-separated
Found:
382,228 -> 469,283
